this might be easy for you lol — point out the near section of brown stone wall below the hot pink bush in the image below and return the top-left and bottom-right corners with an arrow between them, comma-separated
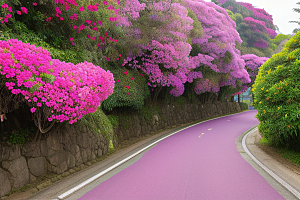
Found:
0,123 -> 109,197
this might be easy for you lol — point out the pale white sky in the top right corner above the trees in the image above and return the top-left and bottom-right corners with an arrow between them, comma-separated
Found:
204,0 -> 300,34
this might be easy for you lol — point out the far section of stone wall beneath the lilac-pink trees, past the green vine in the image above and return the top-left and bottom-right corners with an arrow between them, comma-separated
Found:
113,102 -> 241,147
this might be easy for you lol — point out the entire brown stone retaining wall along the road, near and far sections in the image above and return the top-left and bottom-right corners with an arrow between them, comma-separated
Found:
0,102 -> 241,197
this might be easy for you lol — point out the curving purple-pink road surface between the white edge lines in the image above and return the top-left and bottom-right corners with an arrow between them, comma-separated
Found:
80,110 -> 284,200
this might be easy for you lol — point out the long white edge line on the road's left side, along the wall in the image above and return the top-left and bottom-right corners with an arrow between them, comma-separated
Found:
57,111 -> 249,199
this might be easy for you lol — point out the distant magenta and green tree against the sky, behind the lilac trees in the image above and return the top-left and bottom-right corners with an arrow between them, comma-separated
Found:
219,0 -> 277,57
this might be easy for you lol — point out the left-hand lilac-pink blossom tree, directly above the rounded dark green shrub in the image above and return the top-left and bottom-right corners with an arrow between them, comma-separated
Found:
121,1 -> 193,96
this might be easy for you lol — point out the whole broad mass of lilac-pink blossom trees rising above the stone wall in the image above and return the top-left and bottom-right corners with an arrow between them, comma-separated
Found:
120,0 -> 250,97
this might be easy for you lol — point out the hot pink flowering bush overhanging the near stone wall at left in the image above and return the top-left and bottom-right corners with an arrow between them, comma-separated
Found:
0,39 -> 114,124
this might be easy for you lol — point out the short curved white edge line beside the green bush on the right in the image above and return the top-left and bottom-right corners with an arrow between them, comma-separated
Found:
242,127 -> 300,199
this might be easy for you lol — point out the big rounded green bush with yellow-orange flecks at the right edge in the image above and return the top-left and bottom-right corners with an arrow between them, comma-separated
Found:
253,32 -> 300,150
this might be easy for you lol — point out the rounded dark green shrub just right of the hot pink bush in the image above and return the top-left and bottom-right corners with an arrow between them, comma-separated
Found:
102,67 -> 150,111
